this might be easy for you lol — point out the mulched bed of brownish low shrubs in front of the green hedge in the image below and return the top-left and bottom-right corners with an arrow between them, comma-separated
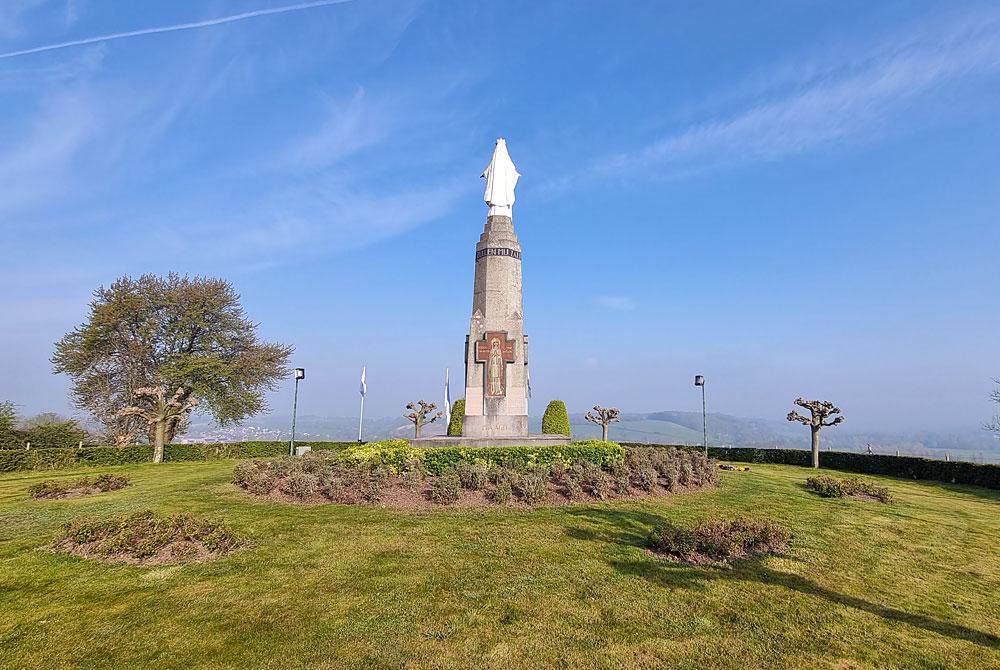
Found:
233,448 -> 718,509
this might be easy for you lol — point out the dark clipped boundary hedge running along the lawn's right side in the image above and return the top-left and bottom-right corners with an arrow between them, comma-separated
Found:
627,444 -> 1000,489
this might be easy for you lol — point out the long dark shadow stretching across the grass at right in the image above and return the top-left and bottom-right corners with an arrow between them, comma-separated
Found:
567,508 -> 1000,650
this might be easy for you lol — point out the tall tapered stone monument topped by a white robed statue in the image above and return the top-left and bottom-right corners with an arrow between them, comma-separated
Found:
462,138 -> 528,438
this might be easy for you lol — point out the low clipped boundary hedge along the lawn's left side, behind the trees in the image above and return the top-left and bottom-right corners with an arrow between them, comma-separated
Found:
0,442 -> 357,472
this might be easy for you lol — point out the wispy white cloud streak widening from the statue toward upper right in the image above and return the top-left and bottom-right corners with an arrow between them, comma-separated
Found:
545,7 -> 1000,191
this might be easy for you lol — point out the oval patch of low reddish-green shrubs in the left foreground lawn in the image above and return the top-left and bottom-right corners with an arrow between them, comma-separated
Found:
55,510 -> 245,563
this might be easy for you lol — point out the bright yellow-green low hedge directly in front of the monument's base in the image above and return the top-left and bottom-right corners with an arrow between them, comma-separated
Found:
343,440 -> 625,475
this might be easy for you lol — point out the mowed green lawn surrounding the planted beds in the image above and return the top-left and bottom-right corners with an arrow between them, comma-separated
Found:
0,462 -> 1000,670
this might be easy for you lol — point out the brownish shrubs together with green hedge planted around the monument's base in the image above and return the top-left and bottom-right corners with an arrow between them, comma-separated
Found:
233,440 -> 717,504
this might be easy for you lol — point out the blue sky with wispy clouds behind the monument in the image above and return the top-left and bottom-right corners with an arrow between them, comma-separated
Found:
0,0 -> 1000,430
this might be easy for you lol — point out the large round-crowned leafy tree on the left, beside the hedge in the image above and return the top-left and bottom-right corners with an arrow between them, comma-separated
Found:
52,273 -> 292,462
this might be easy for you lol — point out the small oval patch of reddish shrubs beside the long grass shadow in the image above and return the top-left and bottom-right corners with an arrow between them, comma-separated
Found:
650,518 -> 792,563
